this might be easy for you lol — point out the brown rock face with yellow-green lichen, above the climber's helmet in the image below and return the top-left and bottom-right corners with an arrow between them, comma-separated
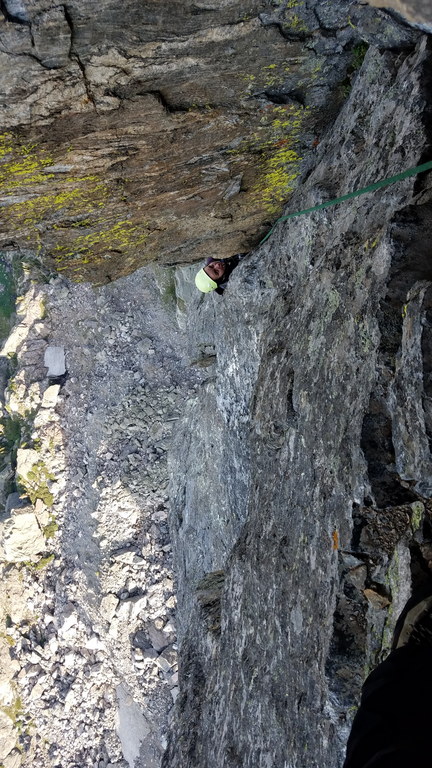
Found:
0,0 -> 416,283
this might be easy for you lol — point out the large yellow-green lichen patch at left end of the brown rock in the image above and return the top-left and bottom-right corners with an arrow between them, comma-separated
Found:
0,133 -> 154,282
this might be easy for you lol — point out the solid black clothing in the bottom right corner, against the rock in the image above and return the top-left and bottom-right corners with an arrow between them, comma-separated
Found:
343,645 -> 432,768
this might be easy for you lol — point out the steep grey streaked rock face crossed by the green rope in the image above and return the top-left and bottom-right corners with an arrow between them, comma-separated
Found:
163,37 -> 432,768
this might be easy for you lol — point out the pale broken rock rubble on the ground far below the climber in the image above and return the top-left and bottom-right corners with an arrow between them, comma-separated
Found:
0,269 -> 198,768
